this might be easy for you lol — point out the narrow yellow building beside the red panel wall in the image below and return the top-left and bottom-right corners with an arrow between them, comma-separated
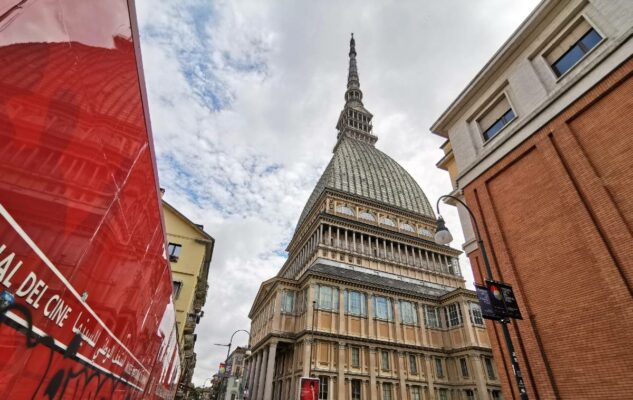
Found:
163,200 -> 215,390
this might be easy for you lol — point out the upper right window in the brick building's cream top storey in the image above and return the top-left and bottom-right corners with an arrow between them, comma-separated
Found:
545,18 -> 602,77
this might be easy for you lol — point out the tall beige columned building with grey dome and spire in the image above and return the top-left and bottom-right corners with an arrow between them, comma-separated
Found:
247,38 -> 501,400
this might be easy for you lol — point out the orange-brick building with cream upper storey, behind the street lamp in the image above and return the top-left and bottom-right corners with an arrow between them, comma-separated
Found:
431,0 -> 633,399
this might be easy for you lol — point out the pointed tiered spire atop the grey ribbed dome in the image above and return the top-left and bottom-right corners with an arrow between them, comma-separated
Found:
334,33 -> 378,151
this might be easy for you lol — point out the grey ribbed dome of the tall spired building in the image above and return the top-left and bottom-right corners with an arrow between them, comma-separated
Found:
297,137 -> 435,227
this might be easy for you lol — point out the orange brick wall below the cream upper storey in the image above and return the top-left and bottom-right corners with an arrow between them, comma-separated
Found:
464,59 -> 633,399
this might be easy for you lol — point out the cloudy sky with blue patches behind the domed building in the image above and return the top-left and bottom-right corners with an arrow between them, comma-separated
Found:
137,0 -> 537,385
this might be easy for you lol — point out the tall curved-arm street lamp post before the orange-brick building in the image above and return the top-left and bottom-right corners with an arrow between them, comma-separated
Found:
435,195 -> 528,400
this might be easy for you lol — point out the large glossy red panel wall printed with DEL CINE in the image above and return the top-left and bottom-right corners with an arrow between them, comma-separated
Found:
0,0 -> 181,399
